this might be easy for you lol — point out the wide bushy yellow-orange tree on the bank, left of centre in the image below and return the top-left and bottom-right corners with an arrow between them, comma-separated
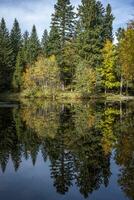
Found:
22,56 -> 60,98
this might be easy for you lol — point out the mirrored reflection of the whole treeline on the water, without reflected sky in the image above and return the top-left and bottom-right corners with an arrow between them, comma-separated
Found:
0,102 -> 134,199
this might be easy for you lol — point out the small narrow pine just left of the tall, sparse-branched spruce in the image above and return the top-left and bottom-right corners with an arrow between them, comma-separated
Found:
41,29 -> 49,56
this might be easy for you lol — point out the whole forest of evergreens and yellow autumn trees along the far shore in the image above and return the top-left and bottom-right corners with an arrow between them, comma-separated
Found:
0,0 -> 134,99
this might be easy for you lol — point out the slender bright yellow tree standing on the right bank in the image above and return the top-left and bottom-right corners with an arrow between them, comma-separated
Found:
98,40 -> 119,93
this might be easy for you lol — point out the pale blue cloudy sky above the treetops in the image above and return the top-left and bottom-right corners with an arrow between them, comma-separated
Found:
0,0 -> 134,38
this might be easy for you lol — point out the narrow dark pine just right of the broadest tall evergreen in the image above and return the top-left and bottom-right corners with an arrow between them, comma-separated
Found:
104,4 -> 114,41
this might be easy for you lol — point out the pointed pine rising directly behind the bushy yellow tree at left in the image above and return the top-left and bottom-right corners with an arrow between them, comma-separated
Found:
28,25 -> 41,65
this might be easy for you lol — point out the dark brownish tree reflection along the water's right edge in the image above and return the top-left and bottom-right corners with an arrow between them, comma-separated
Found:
115,102 -> 134,199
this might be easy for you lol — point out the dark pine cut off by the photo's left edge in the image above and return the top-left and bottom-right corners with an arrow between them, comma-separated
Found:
0,18 -> 13,91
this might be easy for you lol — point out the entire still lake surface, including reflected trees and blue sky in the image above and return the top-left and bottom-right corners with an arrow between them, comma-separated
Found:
0,102 -> 134,200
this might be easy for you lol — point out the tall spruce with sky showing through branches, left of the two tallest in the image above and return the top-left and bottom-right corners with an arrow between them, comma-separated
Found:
48,0 -> 75,86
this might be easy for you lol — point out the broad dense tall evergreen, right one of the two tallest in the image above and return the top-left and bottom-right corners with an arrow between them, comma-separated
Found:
77,0 -> 104,67
